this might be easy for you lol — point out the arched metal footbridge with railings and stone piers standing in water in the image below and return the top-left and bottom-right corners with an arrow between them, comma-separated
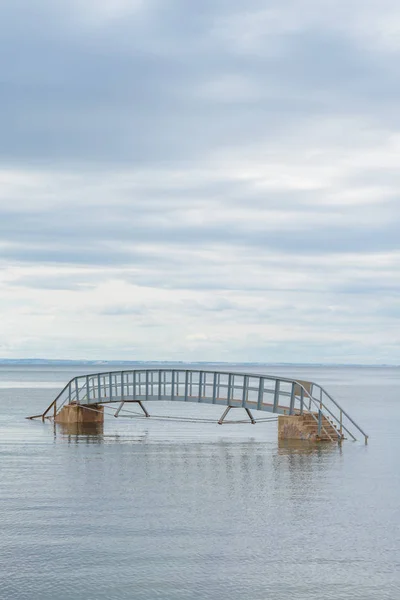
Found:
27,368 -> 368,443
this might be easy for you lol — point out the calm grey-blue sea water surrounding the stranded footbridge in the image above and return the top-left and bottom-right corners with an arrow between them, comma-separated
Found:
0,364 -> 400,600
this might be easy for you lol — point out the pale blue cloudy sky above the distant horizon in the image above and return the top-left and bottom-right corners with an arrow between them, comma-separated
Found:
0,0 -> 400,364
